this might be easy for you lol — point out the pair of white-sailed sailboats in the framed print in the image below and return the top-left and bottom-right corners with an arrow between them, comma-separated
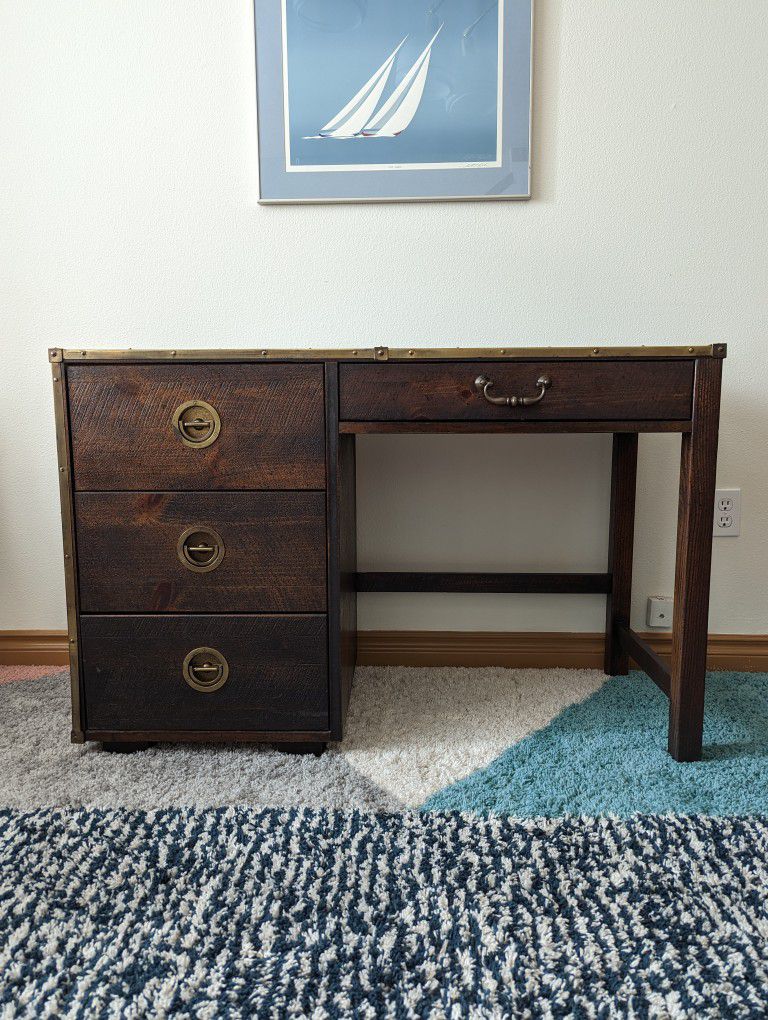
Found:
309,22 -> 445,139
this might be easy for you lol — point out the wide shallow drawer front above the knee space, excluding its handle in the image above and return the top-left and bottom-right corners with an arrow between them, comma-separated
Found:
340,358 -> 694,421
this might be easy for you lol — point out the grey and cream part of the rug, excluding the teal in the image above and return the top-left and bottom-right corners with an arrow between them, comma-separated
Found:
0,666 -> 606,810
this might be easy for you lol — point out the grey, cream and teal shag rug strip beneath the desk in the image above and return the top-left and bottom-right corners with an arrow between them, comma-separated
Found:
0,667 -> 768,818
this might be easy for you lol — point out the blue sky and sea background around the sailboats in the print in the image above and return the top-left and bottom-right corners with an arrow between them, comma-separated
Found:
286,0 -> 505,167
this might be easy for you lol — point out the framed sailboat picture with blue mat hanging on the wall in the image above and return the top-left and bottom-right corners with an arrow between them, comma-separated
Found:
254,0 -> 532,203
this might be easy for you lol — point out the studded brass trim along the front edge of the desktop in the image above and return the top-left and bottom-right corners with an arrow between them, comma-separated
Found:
48,344 -> 727,362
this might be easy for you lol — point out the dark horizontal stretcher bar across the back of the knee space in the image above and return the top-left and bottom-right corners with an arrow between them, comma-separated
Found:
356,570 -> 611,595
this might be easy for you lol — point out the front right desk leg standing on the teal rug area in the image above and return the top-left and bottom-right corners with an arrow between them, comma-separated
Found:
668,358 -> 722,762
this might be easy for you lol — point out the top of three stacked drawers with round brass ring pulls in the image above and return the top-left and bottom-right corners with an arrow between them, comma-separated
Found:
67,364 -> 325,490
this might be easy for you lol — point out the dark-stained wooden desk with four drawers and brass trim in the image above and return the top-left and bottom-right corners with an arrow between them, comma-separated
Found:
50,345 -> 725,761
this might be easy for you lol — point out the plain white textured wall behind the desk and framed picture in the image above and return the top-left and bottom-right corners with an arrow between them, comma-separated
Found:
0,0 -> 768,633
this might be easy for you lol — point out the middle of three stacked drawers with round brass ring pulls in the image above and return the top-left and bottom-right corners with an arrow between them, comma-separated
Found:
74,493 -> 326,613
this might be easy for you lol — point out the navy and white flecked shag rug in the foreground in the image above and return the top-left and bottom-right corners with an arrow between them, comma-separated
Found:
0,808 -> 768,1020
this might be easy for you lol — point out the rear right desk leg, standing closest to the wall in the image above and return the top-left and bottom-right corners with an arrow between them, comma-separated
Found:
604,432 -> 637,676
